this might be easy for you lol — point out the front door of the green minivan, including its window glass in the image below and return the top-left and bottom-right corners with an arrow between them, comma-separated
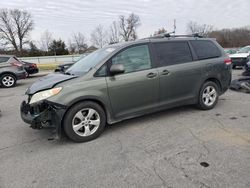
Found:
106,44 -> 159,119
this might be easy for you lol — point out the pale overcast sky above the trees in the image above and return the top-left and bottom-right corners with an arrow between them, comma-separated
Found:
0,0 -> 250,41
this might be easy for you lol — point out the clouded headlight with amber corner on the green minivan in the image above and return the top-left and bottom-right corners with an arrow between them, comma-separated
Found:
30,87 -> 62,104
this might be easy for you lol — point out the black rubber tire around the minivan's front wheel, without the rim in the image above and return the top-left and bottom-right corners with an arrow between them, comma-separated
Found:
63,101 -> 106,142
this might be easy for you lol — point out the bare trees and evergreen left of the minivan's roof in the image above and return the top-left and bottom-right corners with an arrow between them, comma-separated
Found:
0,9 -> 140,56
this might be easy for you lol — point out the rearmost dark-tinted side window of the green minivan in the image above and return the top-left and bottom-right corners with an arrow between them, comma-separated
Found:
191,41 -> 221,60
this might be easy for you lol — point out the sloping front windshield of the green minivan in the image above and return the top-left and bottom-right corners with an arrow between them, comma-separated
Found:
65,48 -> 115,76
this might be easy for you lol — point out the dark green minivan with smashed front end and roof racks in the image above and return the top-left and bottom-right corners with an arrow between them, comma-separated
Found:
21,36 -> 231,142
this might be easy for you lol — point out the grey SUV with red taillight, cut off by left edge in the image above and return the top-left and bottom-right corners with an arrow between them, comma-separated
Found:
0,55 -> 27,88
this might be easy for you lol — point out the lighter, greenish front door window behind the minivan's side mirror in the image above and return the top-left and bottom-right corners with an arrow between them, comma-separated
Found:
112,45 -> 151,73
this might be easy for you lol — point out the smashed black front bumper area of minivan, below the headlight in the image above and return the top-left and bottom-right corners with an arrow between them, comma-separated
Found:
20,100 -> 67,139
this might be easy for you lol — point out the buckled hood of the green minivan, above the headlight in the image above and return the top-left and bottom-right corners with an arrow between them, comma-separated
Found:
26,73 -> 76,95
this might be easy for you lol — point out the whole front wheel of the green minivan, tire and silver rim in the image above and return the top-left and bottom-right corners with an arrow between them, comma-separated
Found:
63,101 -> 106,142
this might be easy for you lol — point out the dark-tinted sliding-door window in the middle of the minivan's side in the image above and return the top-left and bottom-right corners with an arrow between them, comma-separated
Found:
154,42 -> 193,66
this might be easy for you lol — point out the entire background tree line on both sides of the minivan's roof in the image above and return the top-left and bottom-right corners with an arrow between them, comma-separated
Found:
0,9 -> 250,56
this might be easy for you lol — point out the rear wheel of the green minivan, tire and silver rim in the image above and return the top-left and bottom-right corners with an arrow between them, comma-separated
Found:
198,81 -> 219,110
